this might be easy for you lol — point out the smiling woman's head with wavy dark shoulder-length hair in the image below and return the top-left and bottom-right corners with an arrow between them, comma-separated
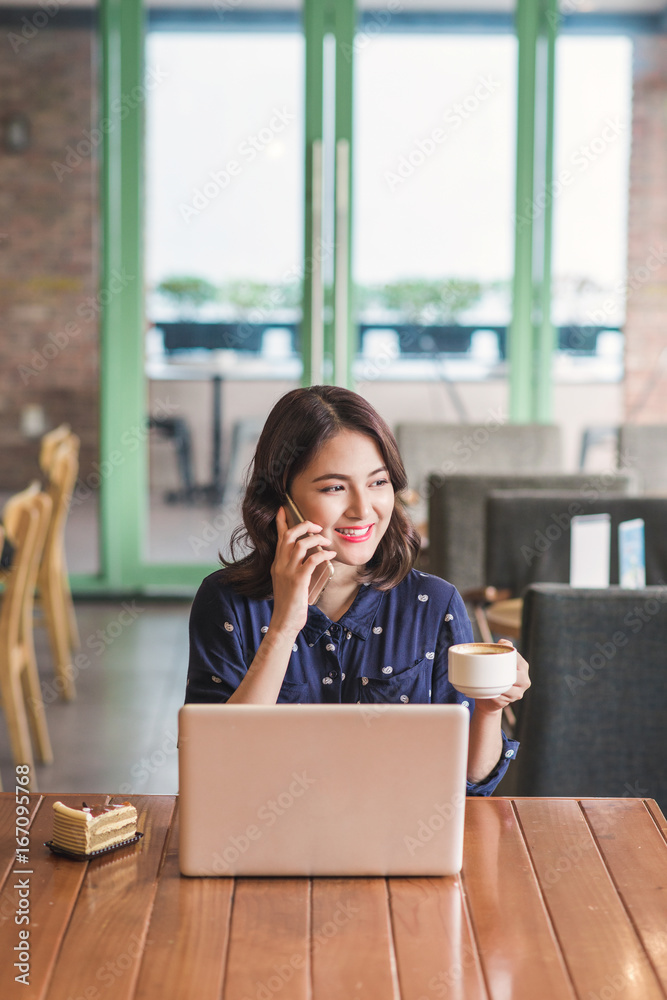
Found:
224,386 -> 419,597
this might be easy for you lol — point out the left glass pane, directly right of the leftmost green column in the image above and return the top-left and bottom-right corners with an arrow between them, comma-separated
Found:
145,22 -> 304,564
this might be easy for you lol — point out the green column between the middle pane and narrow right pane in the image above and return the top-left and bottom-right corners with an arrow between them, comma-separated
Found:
508,0 -> 559,423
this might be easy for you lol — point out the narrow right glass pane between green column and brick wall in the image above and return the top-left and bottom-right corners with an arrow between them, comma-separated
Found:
552,36 -> 632,469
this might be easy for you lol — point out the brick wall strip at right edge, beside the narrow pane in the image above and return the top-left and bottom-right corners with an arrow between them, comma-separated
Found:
625,36 -> 667,424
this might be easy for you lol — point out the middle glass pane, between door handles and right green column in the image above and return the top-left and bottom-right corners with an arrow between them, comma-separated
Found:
354,29 -> 516,506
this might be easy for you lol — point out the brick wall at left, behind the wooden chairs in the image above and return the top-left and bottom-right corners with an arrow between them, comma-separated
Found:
0,27 -> 99,490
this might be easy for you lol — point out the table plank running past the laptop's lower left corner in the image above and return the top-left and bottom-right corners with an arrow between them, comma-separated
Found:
134,810 -> 234,1000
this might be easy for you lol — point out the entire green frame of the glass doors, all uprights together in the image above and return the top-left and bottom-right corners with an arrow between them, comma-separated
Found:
77,0 -> 559,594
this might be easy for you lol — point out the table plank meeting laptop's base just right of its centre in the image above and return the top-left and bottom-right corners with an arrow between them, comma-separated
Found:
311,878 -> 399,1000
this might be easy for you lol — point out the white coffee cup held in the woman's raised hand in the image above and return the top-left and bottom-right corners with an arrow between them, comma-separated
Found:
449,642 -> 516,698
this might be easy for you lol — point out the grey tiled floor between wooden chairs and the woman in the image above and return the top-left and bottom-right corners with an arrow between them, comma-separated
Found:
0,599 -> 190,794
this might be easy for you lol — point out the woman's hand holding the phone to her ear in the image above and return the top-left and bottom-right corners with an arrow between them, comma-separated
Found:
271,507 -> 334,636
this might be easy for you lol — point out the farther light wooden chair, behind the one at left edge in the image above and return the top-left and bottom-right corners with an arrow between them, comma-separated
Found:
37,432 -> 80,701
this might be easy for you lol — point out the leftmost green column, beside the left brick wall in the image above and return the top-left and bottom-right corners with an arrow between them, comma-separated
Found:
100,0 -> 148,590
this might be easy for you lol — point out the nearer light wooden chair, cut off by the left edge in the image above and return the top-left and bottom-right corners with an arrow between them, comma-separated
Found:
0,483 -> 53,790
